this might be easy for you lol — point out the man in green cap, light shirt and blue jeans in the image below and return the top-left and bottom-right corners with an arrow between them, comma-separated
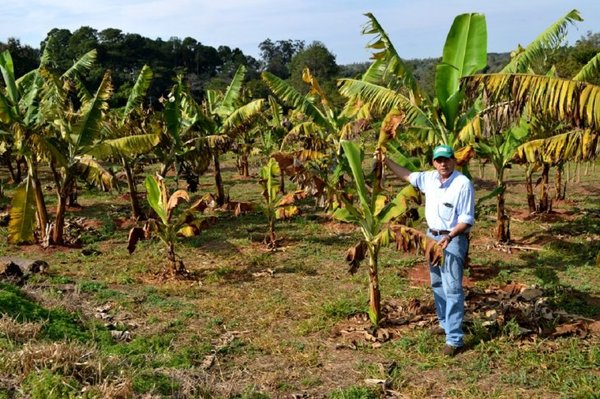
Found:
384,145 -> 475,356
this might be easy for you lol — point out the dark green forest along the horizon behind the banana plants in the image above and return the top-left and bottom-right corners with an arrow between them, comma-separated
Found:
0,26 -> 600,106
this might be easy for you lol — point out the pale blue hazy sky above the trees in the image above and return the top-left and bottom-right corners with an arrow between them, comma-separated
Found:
0,0 -> 600,65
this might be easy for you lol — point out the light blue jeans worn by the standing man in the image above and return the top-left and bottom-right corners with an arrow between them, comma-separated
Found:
428,234 -> 469,347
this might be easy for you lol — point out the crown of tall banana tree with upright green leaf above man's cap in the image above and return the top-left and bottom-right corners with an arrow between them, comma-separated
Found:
340,14 -> 487,153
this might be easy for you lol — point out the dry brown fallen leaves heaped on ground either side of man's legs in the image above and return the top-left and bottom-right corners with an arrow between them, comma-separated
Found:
331,284 -> 600,350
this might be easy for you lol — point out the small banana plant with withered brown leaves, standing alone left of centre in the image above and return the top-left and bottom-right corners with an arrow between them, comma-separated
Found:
127,175 -> 203,277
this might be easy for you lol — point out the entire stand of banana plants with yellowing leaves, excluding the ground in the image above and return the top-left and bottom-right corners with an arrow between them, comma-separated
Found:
0,10 -> 600,323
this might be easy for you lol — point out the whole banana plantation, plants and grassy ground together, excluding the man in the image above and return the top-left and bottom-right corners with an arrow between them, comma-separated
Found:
0,10 -> 600,398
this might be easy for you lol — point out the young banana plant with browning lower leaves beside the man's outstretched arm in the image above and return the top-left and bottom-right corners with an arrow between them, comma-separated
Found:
333,140 -> 442,326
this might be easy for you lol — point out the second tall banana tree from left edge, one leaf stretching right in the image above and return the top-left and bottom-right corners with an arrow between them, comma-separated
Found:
40,65 -> 157,245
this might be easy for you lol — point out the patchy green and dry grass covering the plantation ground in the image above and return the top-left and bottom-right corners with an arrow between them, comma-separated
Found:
0,159 -> 600,398
